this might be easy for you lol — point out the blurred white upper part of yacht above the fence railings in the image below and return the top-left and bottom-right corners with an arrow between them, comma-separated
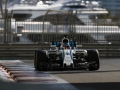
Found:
4,0 -> 108,19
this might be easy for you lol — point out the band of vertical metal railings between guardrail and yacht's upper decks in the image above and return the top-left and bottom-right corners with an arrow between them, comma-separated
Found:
0,15 -> 120,44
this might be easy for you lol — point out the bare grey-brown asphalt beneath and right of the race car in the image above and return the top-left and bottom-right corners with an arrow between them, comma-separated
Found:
21,59 -> 120,90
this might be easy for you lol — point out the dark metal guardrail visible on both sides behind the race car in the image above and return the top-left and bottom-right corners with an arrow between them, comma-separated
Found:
0,44 -> 120,60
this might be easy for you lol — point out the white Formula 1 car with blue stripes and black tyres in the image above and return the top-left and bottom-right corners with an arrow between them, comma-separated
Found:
34,36 -> 100,71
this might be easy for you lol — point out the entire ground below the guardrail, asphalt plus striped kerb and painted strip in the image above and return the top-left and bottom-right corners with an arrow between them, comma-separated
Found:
0,59 -> 120,90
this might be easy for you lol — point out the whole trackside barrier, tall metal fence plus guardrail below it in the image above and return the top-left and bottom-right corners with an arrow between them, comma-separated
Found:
0,9 -> 120,59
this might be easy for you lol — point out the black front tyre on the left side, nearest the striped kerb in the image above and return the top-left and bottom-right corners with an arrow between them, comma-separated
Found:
34,50 -> 47,71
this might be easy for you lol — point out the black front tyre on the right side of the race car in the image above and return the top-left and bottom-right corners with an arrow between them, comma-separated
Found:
87,50 -> 100,71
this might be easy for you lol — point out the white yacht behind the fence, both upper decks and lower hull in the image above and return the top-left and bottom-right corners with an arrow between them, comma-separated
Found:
0,0 -> 117,43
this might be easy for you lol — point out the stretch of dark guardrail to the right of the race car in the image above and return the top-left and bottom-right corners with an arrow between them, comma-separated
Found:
82,44 -> 120,58
